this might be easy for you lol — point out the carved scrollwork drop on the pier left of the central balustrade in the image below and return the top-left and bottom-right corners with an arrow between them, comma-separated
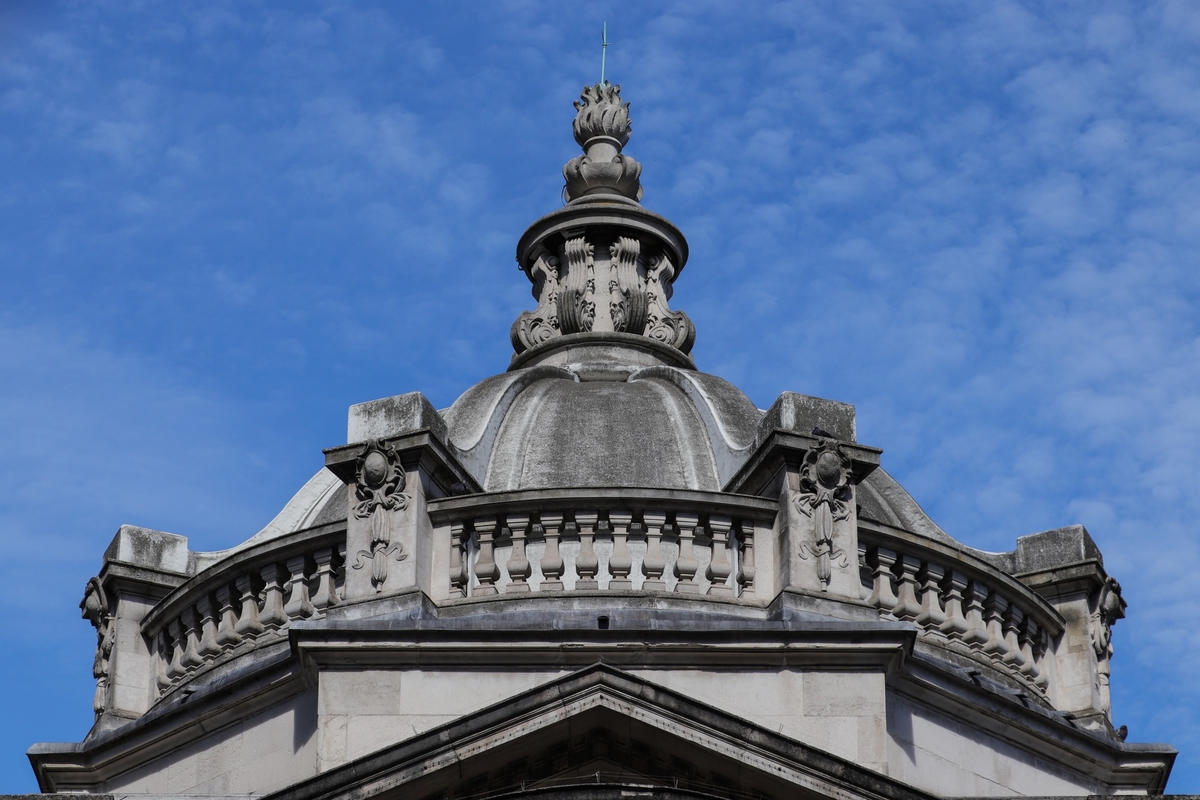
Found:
353,439 -> 408,591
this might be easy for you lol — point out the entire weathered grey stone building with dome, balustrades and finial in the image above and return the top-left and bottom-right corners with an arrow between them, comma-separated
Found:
29,84 -> 1175,800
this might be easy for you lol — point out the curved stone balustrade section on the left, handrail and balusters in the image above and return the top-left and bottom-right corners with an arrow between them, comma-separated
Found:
142,524 -> 346,697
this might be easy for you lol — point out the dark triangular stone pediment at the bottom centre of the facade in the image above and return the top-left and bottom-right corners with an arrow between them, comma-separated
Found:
271,664 -> 929,800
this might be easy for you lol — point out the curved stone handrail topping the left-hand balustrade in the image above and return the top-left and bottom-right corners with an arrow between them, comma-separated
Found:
142,521 -> 346,637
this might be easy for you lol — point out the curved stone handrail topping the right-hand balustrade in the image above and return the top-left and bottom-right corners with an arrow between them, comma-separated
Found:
858,519 -> 1067,637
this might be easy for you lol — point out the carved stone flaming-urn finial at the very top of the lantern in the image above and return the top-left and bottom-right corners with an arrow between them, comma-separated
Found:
563,83 -> 642,201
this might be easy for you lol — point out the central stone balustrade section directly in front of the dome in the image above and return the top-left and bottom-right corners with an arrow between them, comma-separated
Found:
430,489 -> 778,600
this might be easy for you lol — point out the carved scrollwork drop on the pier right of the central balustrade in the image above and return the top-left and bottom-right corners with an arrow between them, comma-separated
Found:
796,444 -> 853,590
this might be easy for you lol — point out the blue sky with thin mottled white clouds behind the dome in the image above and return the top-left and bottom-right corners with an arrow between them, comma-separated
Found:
0,0 -> 1200,793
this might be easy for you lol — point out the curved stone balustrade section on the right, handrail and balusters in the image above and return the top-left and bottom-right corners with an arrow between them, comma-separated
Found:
858,525 -> 1064,698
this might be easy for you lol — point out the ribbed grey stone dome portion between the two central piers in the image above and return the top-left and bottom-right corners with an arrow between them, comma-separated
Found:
443,333 -> 762,492
